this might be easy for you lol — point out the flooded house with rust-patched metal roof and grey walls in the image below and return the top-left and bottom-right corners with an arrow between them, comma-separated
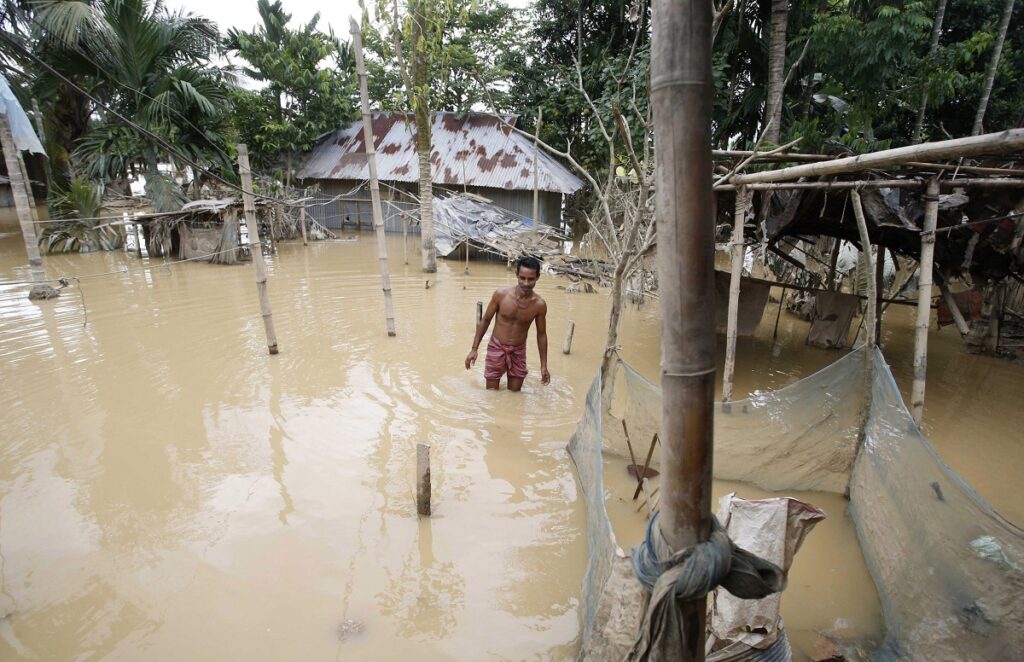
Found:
296,112 -> 583,232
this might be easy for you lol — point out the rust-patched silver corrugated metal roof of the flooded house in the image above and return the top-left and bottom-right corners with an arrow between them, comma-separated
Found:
297,113 -> 583,194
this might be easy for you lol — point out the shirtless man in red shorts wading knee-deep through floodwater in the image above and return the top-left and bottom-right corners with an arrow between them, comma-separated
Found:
466,257 -> 551,390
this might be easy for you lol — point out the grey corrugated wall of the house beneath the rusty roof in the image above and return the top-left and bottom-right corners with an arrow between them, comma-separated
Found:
305,179 -> 562,233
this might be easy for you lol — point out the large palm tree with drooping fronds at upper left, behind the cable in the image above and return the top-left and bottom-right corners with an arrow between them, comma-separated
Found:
22,0 -> 231,206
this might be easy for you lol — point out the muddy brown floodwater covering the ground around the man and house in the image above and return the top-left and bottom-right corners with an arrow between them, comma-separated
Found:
0,215 -> 1024,660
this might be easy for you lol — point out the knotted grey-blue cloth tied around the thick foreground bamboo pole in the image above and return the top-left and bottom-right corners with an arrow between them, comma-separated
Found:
627,512 -> 785,662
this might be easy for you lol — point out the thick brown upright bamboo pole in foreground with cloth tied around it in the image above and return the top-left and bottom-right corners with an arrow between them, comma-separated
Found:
650,0 -> 715,651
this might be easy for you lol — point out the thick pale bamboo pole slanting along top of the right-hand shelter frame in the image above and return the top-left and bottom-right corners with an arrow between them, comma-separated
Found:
733,129 -> 1024,185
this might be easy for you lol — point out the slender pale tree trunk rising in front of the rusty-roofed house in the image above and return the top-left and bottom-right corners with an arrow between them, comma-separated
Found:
409,0 -> 437,274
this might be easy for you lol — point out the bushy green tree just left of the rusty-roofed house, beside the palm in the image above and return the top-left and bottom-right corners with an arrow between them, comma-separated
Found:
225,0 -> 357,171
